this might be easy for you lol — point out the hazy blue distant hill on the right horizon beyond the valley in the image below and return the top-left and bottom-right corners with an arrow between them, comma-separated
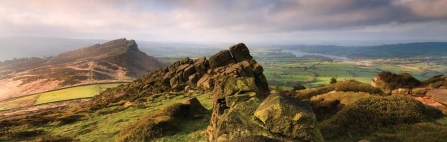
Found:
284,42 -> 447,59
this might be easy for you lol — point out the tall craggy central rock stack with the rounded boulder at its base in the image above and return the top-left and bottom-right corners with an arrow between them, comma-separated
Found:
205,44 -> 324,141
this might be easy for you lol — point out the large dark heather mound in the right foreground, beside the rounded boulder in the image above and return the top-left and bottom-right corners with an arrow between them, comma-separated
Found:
321,96 -> 426,138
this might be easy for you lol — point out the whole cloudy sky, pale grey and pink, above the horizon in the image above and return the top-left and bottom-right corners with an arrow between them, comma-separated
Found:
0,0 -> 447,43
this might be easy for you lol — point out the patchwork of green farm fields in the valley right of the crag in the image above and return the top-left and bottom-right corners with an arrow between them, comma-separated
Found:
252,49 -> 447,89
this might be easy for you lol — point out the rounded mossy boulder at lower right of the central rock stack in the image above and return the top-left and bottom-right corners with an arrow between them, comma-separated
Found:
254,94 -> 324,142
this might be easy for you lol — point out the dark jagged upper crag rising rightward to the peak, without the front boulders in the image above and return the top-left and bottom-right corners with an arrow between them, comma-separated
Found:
95,43 -> 269,105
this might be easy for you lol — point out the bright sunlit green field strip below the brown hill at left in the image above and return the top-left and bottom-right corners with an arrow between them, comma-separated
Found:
35,83 -> 126,105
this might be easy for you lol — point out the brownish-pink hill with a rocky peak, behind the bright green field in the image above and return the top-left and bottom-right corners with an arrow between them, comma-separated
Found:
0,39 -> 163,100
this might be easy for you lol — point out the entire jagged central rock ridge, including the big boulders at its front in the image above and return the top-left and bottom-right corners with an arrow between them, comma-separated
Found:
92,43 -> 324,142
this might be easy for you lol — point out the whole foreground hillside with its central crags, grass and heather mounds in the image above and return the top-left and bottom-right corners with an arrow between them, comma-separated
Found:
0,43 -> 447,142
